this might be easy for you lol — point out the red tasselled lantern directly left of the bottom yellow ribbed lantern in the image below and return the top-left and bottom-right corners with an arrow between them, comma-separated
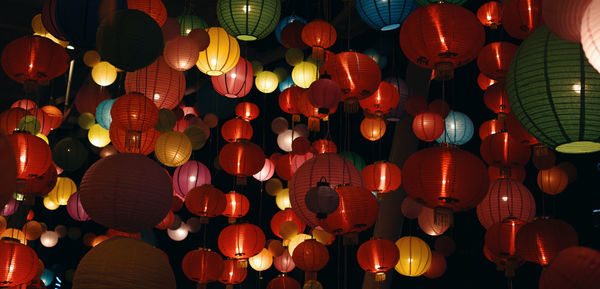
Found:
356,239 -> 400,281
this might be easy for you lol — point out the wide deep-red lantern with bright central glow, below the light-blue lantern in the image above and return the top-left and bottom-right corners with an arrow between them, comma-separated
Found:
402,146 -> 489,213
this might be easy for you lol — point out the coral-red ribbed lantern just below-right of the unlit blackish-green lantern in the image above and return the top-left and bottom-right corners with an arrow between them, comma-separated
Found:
124,56 -> 185,109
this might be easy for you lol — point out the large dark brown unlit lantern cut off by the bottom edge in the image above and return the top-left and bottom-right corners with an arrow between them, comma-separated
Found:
73,237 -> 176,289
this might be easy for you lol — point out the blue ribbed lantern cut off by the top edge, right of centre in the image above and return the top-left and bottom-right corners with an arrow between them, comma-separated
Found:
356,0 -> 419,31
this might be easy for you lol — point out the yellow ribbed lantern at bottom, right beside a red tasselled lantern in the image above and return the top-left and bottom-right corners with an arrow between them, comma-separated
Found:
395,236 -> 431,277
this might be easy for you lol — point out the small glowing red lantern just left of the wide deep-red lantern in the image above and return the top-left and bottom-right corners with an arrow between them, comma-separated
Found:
360,161 -> 402,194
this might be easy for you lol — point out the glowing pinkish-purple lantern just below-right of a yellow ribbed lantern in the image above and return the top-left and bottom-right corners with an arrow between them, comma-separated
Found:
173,160 -> 210,199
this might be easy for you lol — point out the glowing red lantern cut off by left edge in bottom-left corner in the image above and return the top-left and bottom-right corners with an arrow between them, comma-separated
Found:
0,240 -> 39,286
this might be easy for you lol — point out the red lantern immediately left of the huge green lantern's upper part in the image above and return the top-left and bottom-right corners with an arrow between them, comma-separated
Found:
477,42 -> 519,80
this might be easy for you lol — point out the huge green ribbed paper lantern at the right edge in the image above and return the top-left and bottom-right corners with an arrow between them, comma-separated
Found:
506,26 -> 600,153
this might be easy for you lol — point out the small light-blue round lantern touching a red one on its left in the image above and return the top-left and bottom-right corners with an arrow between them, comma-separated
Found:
436,111 -> 474,145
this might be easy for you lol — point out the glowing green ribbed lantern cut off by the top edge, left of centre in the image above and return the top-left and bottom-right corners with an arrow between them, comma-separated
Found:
217,0 -> 281,41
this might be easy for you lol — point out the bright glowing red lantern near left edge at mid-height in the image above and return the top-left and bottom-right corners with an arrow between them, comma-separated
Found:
8,133 -> 52,179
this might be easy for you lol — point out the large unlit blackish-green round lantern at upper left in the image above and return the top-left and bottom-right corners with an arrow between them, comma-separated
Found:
96,9 -> 163,71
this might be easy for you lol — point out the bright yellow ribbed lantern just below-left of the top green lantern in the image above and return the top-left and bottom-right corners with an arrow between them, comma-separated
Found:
196,27 -> 240,76
